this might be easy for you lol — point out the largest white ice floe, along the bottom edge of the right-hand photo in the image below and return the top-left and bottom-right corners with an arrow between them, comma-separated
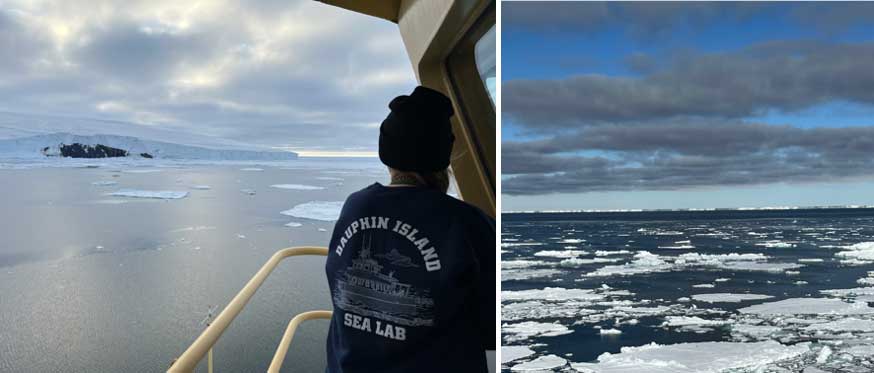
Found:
571,341 -> 810,373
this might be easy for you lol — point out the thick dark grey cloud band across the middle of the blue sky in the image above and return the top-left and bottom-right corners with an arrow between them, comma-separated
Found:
503,41 -> 874,131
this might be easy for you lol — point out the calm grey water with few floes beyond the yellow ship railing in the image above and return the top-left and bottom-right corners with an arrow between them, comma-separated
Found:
0,159 -> 385,372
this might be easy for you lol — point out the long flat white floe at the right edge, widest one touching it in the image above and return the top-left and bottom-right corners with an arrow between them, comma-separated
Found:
738,298 -> 874,316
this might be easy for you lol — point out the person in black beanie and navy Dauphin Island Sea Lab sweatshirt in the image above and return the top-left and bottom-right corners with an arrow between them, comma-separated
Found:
325,86 -> 497,373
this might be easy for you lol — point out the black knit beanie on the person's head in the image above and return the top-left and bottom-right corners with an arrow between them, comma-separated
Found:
379,86 -> 455,173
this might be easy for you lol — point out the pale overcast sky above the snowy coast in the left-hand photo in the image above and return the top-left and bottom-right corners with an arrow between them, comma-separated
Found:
0,0 -> 415,152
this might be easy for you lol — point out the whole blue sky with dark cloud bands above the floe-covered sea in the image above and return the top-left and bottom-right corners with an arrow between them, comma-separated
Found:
502,2 -> 874,211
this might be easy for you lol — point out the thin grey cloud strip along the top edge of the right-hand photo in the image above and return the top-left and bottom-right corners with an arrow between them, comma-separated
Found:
501,1 -> 874,37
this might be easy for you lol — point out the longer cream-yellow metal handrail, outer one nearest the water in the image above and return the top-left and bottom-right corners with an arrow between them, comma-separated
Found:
167,246 -> 328,373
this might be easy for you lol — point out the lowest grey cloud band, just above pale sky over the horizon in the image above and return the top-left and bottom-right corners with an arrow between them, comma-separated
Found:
502,123 -> 874,195
